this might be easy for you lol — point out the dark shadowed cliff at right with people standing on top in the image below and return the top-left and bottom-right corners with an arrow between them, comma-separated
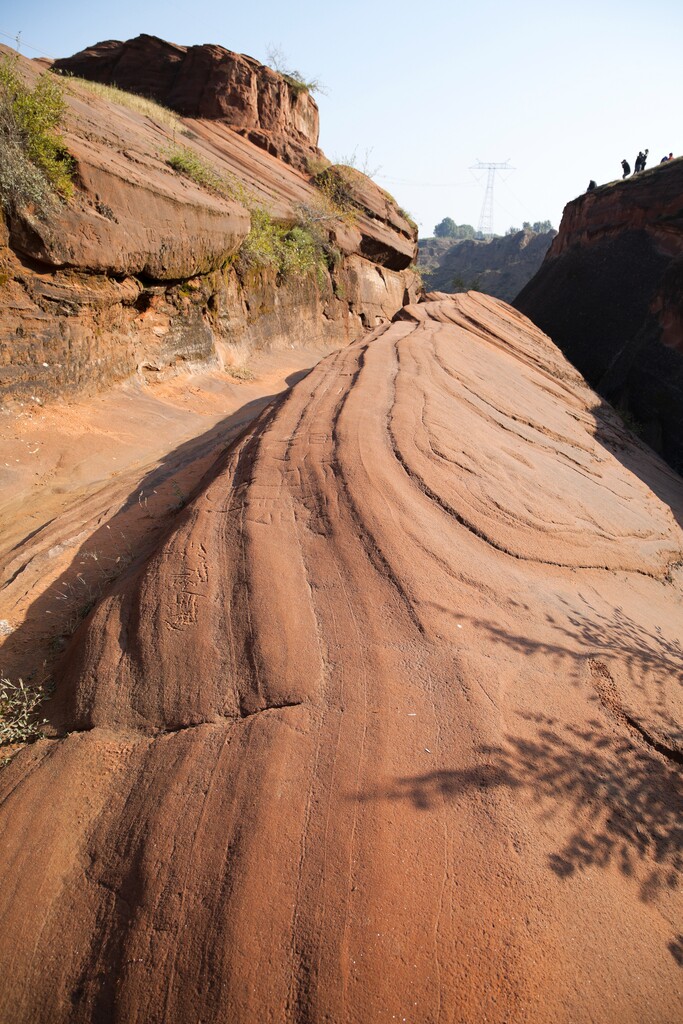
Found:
515,160 -> 683,471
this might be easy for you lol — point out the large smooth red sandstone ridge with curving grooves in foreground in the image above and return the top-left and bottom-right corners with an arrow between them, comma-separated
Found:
0,294 -> 683,1024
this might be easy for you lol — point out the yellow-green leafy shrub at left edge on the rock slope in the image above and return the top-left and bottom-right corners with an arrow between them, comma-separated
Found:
0,56 -> 74,213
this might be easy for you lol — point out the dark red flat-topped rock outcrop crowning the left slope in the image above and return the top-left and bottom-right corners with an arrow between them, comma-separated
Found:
55,35 -> 322,171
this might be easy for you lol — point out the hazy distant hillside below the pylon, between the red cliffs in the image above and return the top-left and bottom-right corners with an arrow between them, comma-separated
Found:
418,230 -> 557,302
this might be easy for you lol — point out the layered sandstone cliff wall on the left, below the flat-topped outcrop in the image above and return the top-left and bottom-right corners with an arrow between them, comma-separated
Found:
0,47 -> 417,399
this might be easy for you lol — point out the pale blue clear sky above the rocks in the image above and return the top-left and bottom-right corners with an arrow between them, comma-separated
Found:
0,0 -> 683,237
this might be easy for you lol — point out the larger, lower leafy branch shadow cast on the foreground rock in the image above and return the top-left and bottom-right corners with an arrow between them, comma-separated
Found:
360,715 -> 683,909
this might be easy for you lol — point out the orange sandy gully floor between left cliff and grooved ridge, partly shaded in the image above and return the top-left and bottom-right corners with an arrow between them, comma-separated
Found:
0,347 -> 325,683
